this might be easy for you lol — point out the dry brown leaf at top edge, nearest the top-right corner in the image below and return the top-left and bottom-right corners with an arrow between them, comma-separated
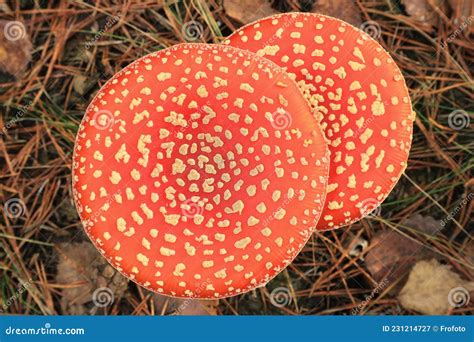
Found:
402,0 -> 446,31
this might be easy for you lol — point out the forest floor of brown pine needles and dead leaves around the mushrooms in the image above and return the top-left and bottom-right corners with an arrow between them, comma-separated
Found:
0,0 -> 474,315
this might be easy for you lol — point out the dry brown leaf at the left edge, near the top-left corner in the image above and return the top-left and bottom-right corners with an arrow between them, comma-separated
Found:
0,20 -> 32,78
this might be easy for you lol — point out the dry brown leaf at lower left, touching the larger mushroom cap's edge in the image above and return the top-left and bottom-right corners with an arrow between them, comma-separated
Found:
56,242 -> 128,315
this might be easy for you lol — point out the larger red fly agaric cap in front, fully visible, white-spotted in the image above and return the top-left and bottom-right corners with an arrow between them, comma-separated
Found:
73,44 -> 329,298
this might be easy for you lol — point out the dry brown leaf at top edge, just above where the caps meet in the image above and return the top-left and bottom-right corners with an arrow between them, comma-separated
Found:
224,0 -> 280,24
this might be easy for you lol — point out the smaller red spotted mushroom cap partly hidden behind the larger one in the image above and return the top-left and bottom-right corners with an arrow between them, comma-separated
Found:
224,13 -> 414,230
